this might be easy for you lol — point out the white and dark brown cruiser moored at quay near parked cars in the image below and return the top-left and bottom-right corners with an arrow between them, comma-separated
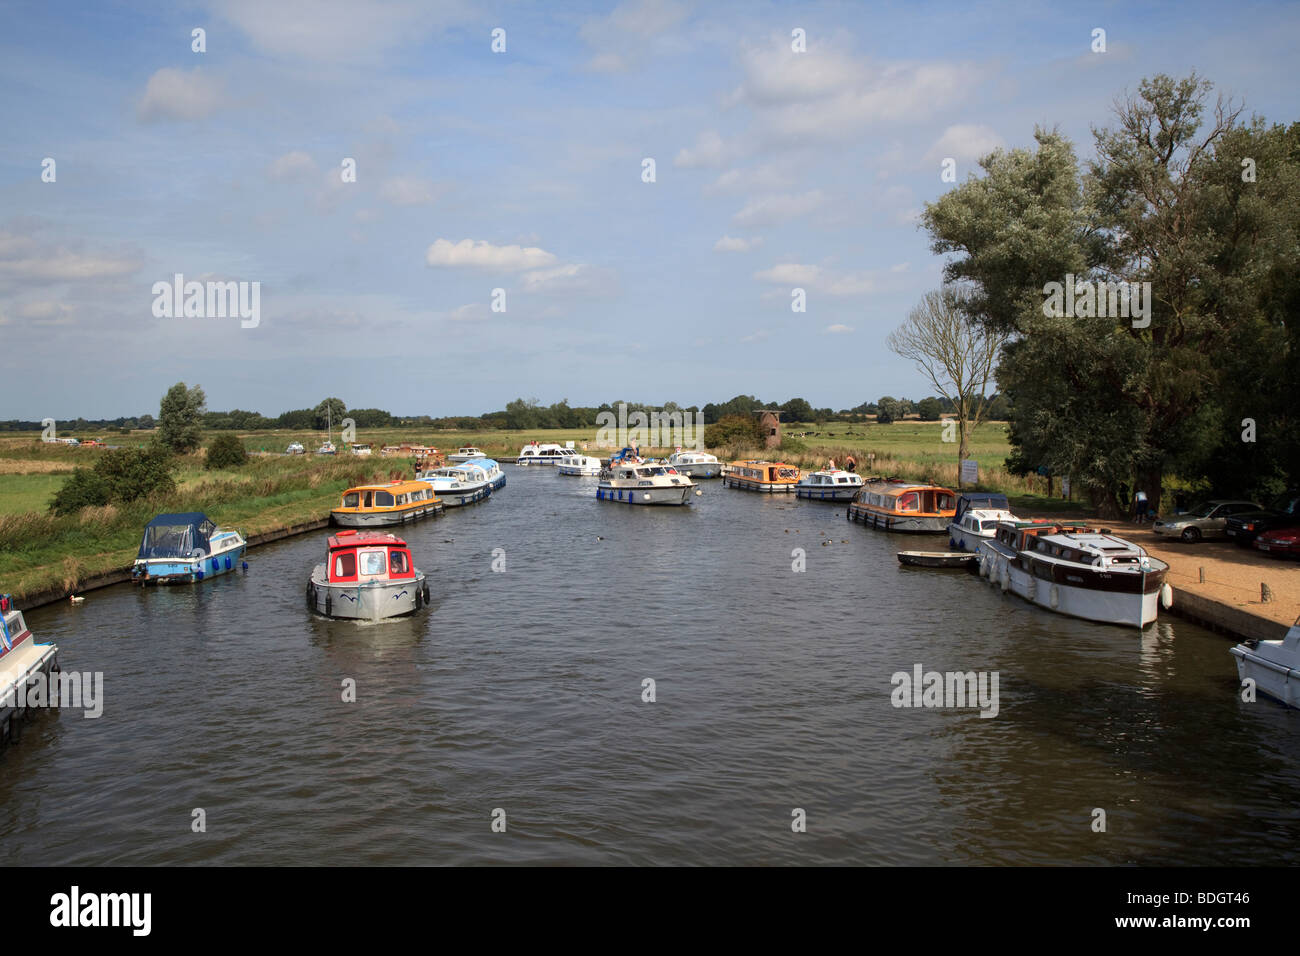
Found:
978,522 -> 1174,628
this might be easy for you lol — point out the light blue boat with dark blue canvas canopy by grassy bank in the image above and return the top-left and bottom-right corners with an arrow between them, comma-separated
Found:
131,511 -> 248,585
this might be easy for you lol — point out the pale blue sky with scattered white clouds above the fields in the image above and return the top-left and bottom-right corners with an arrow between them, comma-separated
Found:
0,0 -> 1300,419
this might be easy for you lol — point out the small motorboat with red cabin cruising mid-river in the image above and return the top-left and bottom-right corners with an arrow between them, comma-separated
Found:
307,529 -> 429,620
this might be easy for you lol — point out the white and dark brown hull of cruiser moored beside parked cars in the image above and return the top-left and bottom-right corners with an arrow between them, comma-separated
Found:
979,541 -> 1166,628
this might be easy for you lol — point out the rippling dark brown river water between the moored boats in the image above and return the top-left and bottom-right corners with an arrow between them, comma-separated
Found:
0,468 -> 1300,864
